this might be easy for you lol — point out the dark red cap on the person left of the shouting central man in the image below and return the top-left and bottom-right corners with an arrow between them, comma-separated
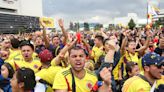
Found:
39,49 -> 53,63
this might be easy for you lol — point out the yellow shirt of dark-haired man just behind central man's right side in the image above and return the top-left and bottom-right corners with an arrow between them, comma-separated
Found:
91,46 -> 105,63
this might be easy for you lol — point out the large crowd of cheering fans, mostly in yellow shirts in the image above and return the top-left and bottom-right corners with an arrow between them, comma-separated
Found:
0,19 -> 164,92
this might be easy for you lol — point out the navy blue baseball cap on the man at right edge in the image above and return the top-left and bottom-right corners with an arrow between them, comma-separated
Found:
142,52 -> 164,67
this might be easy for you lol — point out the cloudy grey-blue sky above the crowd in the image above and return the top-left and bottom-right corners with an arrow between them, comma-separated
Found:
43,0 -> 164,26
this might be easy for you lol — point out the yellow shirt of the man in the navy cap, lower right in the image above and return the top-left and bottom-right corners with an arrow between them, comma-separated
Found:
122,76 -> 151,92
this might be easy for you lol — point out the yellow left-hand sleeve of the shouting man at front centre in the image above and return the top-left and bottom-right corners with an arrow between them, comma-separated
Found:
52,72 -> 68,89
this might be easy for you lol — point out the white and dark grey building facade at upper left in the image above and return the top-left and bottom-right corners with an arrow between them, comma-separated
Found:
0,0 -> 43,33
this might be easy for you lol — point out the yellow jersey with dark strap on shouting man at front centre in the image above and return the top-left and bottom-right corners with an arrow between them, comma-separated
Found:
53,68 -> 97,92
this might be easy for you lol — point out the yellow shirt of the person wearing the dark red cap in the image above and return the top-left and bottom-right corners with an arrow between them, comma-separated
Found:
36,66 -> 62,92
